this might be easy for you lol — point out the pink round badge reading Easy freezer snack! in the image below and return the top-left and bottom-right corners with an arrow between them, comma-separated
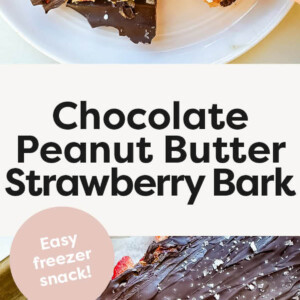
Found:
10,207 -> 114,300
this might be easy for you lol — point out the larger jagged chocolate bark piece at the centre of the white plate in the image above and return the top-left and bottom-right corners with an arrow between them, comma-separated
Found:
67,0 -> 156,44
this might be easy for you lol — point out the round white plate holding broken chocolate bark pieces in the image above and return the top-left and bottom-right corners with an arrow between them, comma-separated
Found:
0,0 -> 293,63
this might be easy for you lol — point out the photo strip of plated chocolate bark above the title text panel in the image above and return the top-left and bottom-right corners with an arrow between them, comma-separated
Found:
0,0 -> 300,64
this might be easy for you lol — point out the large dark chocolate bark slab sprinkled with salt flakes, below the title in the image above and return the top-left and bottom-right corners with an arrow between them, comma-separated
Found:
98,237 -> 300,300
